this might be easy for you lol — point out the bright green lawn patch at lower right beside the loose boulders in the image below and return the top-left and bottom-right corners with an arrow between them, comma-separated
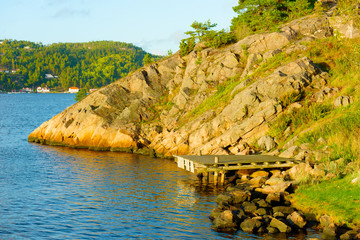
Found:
292,174 -> 360,227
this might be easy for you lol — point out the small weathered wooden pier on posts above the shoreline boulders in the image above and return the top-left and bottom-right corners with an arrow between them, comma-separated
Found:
174,155 -> 298,185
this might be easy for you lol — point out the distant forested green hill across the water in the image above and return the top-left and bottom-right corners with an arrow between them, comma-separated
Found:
0,40 -> 159,91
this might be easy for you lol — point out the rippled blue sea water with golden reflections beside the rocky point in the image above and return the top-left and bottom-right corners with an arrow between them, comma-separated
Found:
0,94 -> 317,239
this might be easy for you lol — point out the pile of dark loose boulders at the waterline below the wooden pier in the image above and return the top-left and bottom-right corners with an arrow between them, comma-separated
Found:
210,163 -> 360,240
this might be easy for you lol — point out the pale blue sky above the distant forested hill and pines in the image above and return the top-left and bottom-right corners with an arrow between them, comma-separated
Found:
0,0 -> 238,55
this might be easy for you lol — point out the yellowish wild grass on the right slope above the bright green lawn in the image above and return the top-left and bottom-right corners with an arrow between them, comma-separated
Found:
270,37 -> 360,162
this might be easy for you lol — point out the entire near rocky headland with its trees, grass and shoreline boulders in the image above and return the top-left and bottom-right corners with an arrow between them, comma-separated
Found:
28,0 -> 360,239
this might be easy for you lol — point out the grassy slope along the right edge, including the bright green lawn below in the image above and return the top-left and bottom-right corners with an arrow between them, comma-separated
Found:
278,37 -> 360,226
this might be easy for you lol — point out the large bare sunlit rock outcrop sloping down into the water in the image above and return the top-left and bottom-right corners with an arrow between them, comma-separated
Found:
28,16 -> 354,156
